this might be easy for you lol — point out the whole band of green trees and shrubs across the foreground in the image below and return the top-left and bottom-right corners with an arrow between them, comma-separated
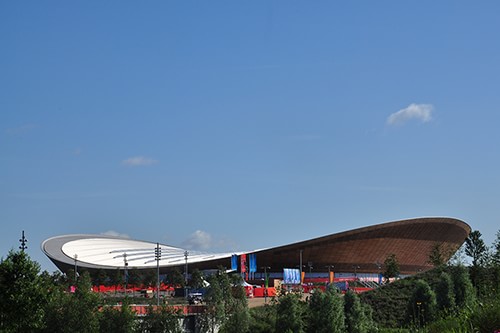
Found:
0,227 -> 500,333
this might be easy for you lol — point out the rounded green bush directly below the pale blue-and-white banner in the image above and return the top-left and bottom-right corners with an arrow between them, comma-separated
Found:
276,293 -> 305,333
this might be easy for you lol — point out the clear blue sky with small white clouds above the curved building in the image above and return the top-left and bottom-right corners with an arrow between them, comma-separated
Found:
0,1 -> 500,271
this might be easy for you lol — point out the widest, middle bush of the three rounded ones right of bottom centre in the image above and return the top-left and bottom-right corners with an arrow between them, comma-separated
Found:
307,288 -> 346,333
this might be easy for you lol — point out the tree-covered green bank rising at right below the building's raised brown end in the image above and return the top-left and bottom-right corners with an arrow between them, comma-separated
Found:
361,231 -> 500,333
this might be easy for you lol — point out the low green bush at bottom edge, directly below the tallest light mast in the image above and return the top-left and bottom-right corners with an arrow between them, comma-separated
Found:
140,305 -> 183,333
